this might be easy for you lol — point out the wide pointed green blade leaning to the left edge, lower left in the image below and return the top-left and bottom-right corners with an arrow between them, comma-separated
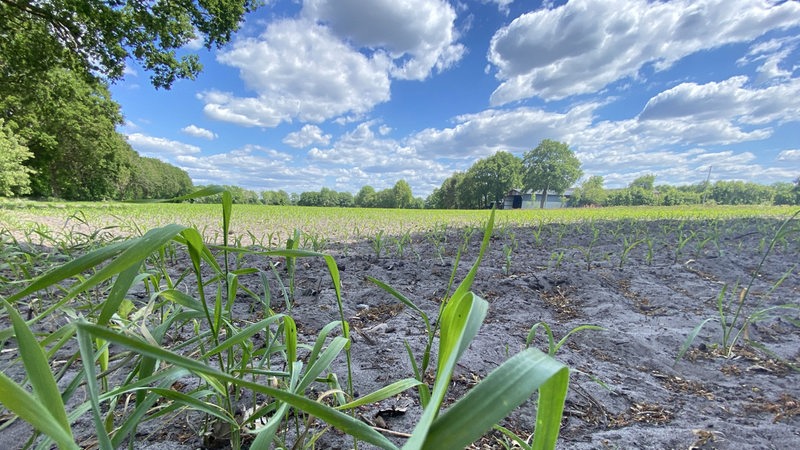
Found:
0,299 -> 72,436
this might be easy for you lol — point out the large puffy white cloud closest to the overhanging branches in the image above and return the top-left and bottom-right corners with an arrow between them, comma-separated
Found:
200,20 -> 390,127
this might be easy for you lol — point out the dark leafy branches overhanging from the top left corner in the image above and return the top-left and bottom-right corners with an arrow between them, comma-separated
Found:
0,0 -> 261,88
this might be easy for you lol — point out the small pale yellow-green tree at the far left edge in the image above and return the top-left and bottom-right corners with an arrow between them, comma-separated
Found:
0,119 -> 33,197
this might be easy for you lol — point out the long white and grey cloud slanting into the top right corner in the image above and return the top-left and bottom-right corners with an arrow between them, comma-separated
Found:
488,0 -> 800,105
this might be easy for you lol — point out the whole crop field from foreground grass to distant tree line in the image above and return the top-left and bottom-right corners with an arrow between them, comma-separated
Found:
0,203 -> 800,450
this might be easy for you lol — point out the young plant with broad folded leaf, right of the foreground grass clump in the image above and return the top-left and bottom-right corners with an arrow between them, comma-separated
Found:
366,211 -> 569,450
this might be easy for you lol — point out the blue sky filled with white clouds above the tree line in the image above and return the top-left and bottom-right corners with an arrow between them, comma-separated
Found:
111,0 -> 800,197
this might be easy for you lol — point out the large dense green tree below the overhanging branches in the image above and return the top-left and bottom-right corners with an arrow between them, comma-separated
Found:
0,69 -> 136,200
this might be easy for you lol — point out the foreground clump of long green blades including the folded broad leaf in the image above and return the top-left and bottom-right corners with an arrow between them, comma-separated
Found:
0,197 -> 569,450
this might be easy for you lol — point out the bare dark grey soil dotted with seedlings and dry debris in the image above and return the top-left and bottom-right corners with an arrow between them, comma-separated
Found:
0,219 -> 800,450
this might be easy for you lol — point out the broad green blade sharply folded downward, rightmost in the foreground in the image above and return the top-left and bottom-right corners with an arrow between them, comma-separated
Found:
423,348 -> 569,449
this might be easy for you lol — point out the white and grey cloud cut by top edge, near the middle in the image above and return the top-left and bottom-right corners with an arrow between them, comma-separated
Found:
303,0 -> 465,80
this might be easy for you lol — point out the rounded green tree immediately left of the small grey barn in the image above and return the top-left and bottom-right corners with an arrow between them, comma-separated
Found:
463,152 -> 522,207
